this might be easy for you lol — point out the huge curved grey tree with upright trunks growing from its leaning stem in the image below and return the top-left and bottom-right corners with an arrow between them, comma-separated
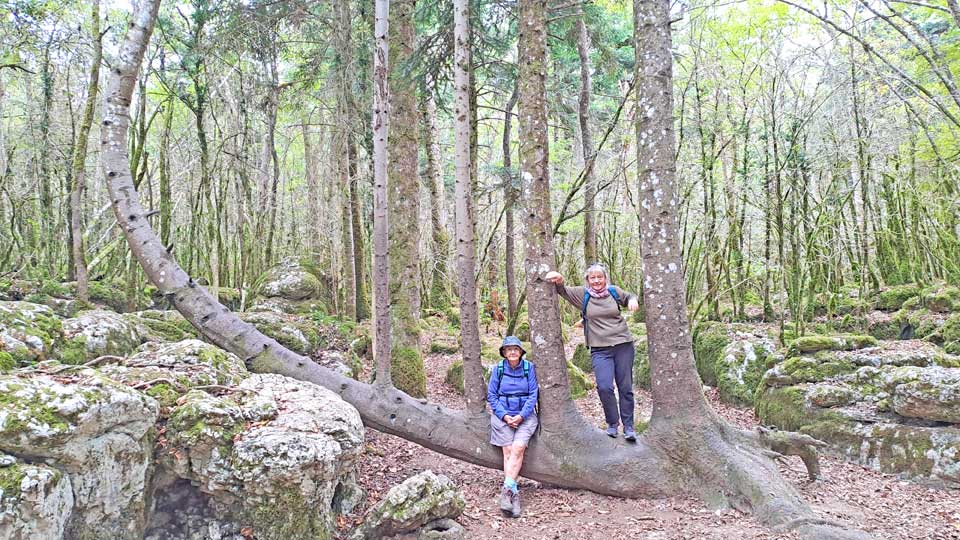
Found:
101,4 -> 864,538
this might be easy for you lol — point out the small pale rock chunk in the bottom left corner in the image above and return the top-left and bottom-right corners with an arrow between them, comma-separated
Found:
0,453 -> 73,540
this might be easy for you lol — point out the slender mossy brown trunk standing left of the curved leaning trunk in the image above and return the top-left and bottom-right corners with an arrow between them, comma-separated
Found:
70,0 -> 103,302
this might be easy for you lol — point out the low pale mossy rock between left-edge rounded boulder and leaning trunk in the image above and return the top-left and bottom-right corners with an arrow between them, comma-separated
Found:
61,310 -> 143,364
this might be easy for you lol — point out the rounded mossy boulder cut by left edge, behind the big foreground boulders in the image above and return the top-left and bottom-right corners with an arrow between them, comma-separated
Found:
0,301 -> 63,366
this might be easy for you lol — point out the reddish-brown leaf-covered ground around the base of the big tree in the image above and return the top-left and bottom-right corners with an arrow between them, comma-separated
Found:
344,334 -> 960,540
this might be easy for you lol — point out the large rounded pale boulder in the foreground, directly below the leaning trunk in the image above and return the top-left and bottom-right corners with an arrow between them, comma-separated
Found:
160,375 -> 363,540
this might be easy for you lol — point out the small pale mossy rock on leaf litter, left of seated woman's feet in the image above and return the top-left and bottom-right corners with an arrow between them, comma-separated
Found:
352,470 -> 466,540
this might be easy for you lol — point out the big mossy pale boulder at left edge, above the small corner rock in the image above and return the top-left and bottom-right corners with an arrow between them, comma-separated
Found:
0,369 -> 158,540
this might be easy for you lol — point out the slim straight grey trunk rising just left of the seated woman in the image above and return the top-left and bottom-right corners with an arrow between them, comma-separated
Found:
453,0 -> 486,417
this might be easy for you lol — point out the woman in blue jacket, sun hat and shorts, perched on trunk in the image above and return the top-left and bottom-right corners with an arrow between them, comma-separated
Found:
487,336 -> 540,517
